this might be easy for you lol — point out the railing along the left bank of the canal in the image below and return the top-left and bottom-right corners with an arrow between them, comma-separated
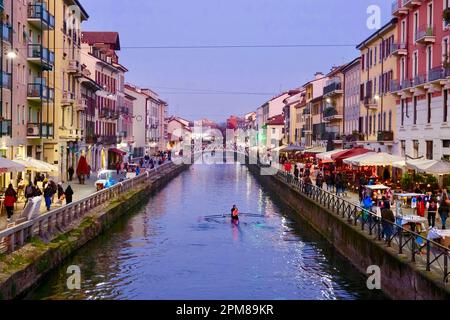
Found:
0,162 -> 172,253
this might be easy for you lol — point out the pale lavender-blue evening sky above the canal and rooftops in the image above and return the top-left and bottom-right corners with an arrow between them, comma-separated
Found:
81,0 -> 391,122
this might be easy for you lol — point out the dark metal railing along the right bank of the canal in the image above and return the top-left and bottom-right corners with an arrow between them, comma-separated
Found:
277,171 -> 450,283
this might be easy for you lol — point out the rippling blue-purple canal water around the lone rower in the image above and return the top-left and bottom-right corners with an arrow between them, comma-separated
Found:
27,164 -> 384,300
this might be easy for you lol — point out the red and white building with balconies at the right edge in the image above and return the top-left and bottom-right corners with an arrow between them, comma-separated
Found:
390,0 -> 450,160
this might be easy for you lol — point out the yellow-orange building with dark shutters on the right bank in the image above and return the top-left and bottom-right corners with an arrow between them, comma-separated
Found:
357,18 -> 399,153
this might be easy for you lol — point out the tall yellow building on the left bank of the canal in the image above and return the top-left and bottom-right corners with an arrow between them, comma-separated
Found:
43,0 -> 88,181
